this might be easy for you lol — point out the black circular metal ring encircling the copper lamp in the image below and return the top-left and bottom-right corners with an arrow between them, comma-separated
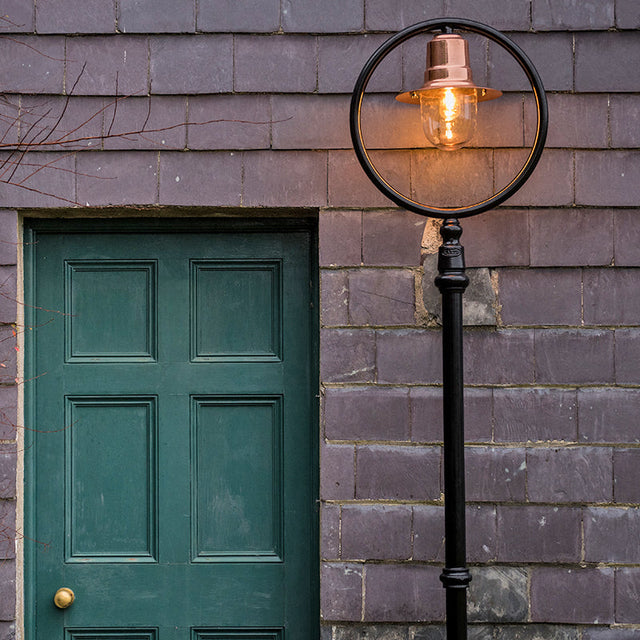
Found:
349,18 -> 549,218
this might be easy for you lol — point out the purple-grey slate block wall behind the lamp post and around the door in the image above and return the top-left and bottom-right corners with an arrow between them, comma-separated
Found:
0,0 -> 640,640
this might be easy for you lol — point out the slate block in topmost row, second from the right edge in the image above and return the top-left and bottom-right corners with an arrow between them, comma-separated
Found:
531,0 -> 614,31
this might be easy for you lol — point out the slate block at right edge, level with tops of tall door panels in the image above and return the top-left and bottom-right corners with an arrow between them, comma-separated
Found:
578,388 -> 640,444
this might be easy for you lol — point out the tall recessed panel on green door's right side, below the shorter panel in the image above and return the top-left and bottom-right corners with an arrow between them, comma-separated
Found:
192,397 -> 283,562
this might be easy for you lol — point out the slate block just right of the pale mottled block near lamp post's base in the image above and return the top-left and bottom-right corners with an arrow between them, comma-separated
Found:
531,567 -> 614,624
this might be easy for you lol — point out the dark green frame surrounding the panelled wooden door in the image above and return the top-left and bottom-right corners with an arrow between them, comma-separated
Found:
21,216 -> 320,640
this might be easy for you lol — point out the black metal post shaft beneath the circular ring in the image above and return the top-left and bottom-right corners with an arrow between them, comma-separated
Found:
435,218 -> 471,640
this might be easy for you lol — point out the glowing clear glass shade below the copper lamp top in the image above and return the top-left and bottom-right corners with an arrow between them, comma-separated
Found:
419,87 -> 478,151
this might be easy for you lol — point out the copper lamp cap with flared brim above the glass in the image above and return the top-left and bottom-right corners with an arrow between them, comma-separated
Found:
396,33 -> 502,104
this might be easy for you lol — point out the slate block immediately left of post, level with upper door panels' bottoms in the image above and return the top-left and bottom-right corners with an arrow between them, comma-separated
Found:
376,329 -> 442,384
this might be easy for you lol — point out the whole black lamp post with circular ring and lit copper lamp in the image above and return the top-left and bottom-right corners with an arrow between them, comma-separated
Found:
350,18 -> 548,640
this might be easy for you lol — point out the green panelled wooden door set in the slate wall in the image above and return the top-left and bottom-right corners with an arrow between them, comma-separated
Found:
25,221 -> 318,640
